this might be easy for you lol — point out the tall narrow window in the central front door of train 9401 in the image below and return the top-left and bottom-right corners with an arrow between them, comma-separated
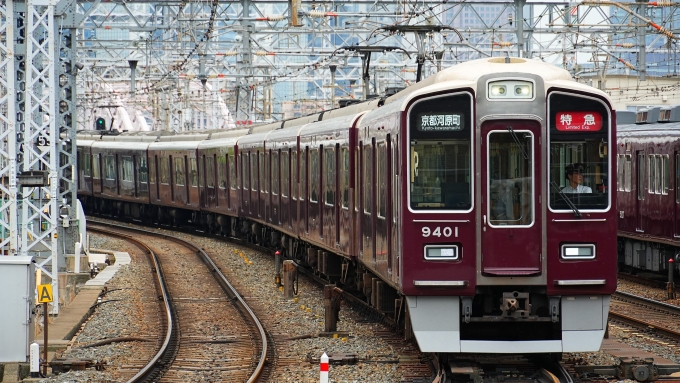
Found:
487,130 -> 535,226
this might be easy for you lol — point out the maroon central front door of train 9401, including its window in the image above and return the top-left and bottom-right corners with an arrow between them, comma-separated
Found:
480,120 -> 544,276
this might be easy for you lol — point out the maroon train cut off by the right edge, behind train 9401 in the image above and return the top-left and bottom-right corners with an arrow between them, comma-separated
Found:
617,106 -> 680,272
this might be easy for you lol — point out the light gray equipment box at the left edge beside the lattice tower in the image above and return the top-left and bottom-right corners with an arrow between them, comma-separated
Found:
0,256 -> 36,363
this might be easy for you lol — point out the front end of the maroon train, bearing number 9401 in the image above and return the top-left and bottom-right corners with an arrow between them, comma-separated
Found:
399,58 -> 616,354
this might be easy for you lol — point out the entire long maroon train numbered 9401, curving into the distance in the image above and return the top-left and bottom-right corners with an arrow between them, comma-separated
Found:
78,58 -> 618,354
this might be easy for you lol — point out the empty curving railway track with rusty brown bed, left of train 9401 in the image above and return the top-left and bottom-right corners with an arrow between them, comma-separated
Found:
88,222 -> 272,383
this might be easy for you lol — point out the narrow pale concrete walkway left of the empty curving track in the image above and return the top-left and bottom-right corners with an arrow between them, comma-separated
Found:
0,250 -> 131,383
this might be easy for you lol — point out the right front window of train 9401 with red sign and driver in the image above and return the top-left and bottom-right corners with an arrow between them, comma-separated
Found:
547,92 -> 612,214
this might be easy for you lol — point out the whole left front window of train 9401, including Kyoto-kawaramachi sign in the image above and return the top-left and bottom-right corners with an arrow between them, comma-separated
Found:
402,93 -> 474,212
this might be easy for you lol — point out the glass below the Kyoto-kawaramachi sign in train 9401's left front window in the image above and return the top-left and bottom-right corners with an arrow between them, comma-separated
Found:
409,140 -> 472,210
